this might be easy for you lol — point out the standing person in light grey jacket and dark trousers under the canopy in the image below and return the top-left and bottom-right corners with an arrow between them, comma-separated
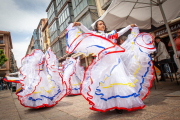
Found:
154,37 -> 170,81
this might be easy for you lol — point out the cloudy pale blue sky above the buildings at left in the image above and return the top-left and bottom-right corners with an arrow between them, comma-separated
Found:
0,0 -> 51,67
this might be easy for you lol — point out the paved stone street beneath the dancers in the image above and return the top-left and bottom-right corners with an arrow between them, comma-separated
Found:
0,80 -> 180,120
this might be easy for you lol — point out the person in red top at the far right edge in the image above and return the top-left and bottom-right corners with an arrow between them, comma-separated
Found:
168,29 -> 180,73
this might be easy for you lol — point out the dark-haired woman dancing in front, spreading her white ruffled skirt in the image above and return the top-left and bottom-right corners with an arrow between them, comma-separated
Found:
67,21 -> 155,112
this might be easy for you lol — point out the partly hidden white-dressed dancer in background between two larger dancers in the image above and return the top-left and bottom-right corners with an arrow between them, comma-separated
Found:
63,57 -> 84,95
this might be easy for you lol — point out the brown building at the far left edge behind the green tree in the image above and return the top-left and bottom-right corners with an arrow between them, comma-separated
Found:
0,31 -> 17,77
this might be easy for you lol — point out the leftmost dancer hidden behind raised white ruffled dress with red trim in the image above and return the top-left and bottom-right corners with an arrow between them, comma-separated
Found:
6,48 -> 67,109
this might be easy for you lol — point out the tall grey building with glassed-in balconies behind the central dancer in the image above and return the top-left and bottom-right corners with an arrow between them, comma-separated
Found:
46,0 -> 99,67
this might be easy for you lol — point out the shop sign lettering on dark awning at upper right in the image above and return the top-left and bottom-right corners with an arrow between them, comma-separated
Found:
155,23 -> 180,36
